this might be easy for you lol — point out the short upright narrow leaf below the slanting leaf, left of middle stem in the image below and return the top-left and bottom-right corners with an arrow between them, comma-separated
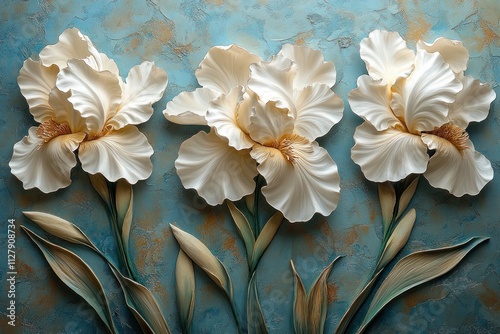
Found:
175,249 -> 195,333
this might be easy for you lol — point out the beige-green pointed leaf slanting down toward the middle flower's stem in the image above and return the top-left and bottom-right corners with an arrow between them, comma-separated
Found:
170,224 -> 233,301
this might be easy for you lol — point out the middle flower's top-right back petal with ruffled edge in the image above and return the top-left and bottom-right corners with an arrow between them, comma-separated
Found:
278,44 -> 337,89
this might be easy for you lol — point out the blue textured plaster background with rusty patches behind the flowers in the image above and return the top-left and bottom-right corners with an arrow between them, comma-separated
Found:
0,0 -> 500,333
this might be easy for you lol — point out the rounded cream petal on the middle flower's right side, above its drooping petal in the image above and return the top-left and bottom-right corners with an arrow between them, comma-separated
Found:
295,84 -> 344,141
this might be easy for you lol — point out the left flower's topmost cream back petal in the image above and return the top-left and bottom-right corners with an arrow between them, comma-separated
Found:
40,28 -> 98,70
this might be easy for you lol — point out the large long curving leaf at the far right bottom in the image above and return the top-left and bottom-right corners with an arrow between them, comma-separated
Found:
358,237 -> 489,333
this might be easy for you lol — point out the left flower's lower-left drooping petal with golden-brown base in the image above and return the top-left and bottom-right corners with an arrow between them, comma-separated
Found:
9,127 -> 85,193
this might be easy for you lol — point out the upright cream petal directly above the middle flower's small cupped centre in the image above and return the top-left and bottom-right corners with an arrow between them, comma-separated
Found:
248,55 -> 297,111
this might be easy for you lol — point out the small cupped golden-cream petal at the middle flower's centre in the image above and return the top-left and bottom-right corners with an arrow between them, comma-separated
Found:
248,101 -> 294,145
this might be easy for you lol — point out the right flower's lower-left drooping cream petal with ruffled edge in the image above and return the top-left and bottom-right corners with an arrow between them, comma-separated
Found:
351,122 -> 429,182
